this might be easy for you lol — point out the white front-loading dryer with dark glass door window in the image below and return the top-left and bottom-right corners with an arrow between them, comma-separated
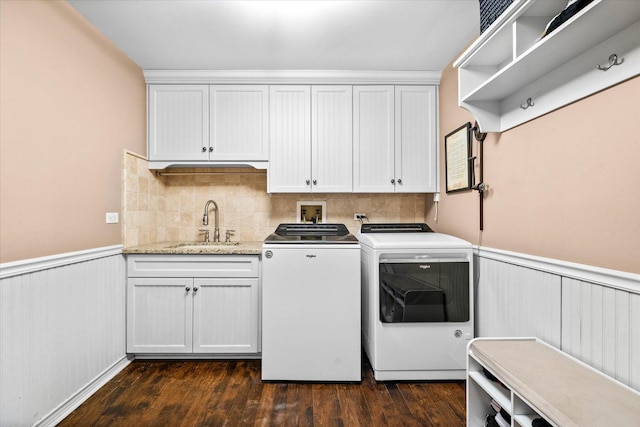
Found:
357,223 -> 474,381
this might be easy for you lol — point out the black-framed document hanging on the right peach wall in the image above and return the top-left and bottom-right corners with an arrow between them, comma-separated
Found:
444,122 -> 472,193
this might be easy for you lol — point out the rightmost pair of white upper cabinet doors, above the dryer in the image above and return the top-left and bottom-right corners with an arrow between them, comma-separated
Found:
353,86 -> 437,193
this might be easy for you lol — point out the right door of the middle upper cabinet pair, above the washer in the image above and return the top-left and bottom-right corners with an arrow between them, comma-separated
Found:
311,86 -> 353,193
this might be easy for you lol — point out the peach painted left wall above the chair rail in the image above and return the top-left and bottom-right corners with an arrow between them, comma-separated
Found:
0,0 -> 146,262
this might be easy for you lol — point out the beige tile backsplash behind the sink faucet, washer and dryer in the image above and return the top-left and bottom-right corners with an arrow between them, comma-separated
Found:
122,151 -> 427,247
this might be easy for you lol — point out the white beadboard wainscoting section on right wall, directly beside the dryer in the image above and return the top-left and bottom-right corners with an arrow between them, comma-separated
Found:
476,257 -> 562,347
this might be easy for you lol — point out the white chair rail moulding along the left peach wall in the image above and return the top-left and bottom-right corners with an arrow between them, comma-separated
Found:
0,245 -> 123,279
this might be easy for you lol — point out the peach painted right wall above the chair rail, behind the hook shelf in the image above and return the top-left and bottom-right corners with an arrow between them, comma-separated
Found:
427,60 -> 640,273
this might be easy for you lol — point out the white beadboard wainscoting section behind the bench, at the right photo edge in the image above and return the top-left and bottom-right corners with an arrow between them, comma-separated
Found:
562,277 -> 640,389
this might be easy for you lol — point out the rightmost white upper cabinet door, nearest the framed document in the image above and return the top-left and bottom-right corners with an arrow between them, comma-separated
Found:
395,86 -> 437,193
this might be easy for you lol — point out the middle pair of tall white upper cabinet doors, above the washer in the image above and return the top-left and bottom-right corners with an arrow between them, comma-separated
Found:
268,85 -> 353,193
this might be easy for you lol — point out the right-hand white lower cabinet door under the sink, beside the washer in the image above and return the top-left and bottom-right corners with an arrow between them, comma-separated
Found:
193,279 -> 260,353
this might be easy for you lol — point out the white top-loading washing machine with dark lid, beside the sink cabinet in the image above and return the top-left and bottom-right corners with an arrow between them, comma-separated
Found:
262,224 -> 362,382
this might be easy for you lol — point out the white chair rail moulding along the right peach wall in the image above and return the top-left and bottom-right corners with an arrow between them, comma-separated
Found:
473,246 -> 640,294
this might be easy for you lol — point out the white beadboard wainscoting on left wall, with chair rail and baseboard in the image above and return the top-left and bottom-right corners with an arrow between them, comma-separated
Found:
0,245 -> 129,426
